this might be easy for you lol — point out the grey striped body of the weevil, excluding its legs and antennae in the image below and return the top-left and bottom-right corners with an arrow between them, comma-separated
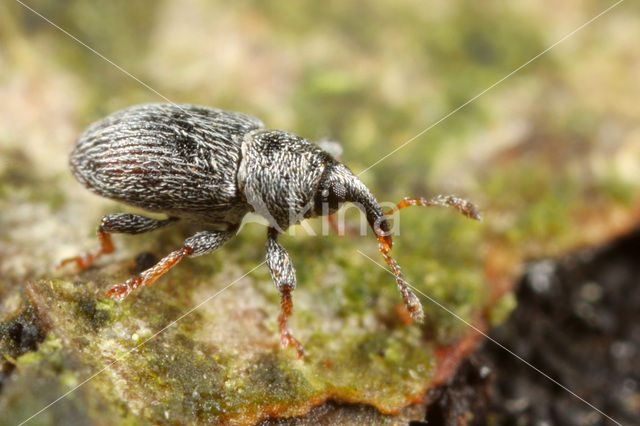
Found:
70,104 -> 383,230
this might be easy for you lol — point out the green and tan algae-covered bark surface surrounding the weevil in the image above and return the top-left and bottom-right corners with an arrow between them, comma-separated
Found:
0,0 -> 640,424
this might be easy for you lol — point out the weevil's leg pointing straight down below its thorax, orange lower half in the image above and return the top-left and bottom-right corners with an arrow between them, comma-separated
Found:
266,228 -> 304,359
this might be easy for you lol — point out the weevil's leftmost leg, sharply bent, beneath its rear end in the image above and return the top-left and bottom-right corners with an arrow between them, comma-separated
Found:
58,213 -> 178,270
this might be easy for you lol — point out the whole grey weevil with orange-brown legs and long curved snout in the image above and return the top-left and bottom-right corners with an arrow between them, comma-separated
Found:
59,104 -> 480,358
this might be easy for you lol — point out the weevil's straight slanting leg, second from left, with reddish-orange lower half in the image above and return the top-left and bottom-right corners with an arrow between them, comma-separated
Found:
107,228 -> 237,300
